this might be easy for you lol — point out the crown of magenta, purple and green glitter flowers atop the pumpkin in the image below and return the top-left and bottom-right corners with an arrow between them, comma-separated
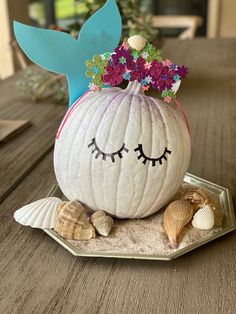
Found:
86,37 -> 188,103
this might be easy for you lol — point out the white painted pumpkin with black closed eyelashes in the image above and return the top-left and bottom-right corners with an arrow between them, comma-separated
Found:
54,82 -> 191,218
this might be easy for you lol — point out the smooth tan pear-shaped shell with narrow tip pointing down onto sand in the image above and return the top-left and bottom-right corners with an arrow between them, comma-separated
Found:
163,200 -> 193,249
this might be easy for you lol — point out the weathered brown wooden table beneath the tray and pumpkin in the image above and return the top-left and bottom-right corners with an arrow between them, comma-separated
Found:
0,39 -> 236,314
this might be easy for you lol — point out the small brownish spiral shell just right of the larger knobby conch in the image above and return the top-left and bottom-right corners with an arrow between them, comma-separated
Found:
90,210 -> 114,237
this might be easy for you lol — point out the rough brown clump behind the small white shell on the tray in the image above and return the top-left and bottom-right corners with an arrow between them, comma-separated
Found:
183,188 -> 224,226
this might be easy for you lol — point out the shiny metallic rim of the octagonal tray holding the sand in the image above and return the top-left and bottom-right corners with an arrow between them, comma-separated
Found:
44,173 -> 236,261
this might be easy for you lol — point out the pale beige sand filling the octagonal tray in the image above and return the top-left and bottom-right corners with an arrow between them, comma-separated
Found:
68,183 -> 221,256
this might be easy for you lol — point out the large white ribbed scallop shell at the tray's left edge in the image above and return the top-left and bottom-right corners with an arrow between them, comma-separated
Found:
14,197 -> 62,229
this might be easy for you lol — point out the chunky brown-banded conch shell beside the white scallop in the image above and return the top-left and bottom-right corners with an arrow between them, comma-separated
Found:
54,201 -> 95,240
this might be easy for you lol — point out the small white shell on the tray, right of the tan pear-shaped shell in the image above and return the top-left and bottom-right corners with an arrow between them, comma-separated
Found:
192,205 -> 215,230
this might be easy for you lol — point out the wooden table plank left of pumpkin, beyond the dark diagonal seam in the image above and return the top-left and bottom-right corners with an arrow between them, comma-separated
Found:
0,73 -> 67,201
